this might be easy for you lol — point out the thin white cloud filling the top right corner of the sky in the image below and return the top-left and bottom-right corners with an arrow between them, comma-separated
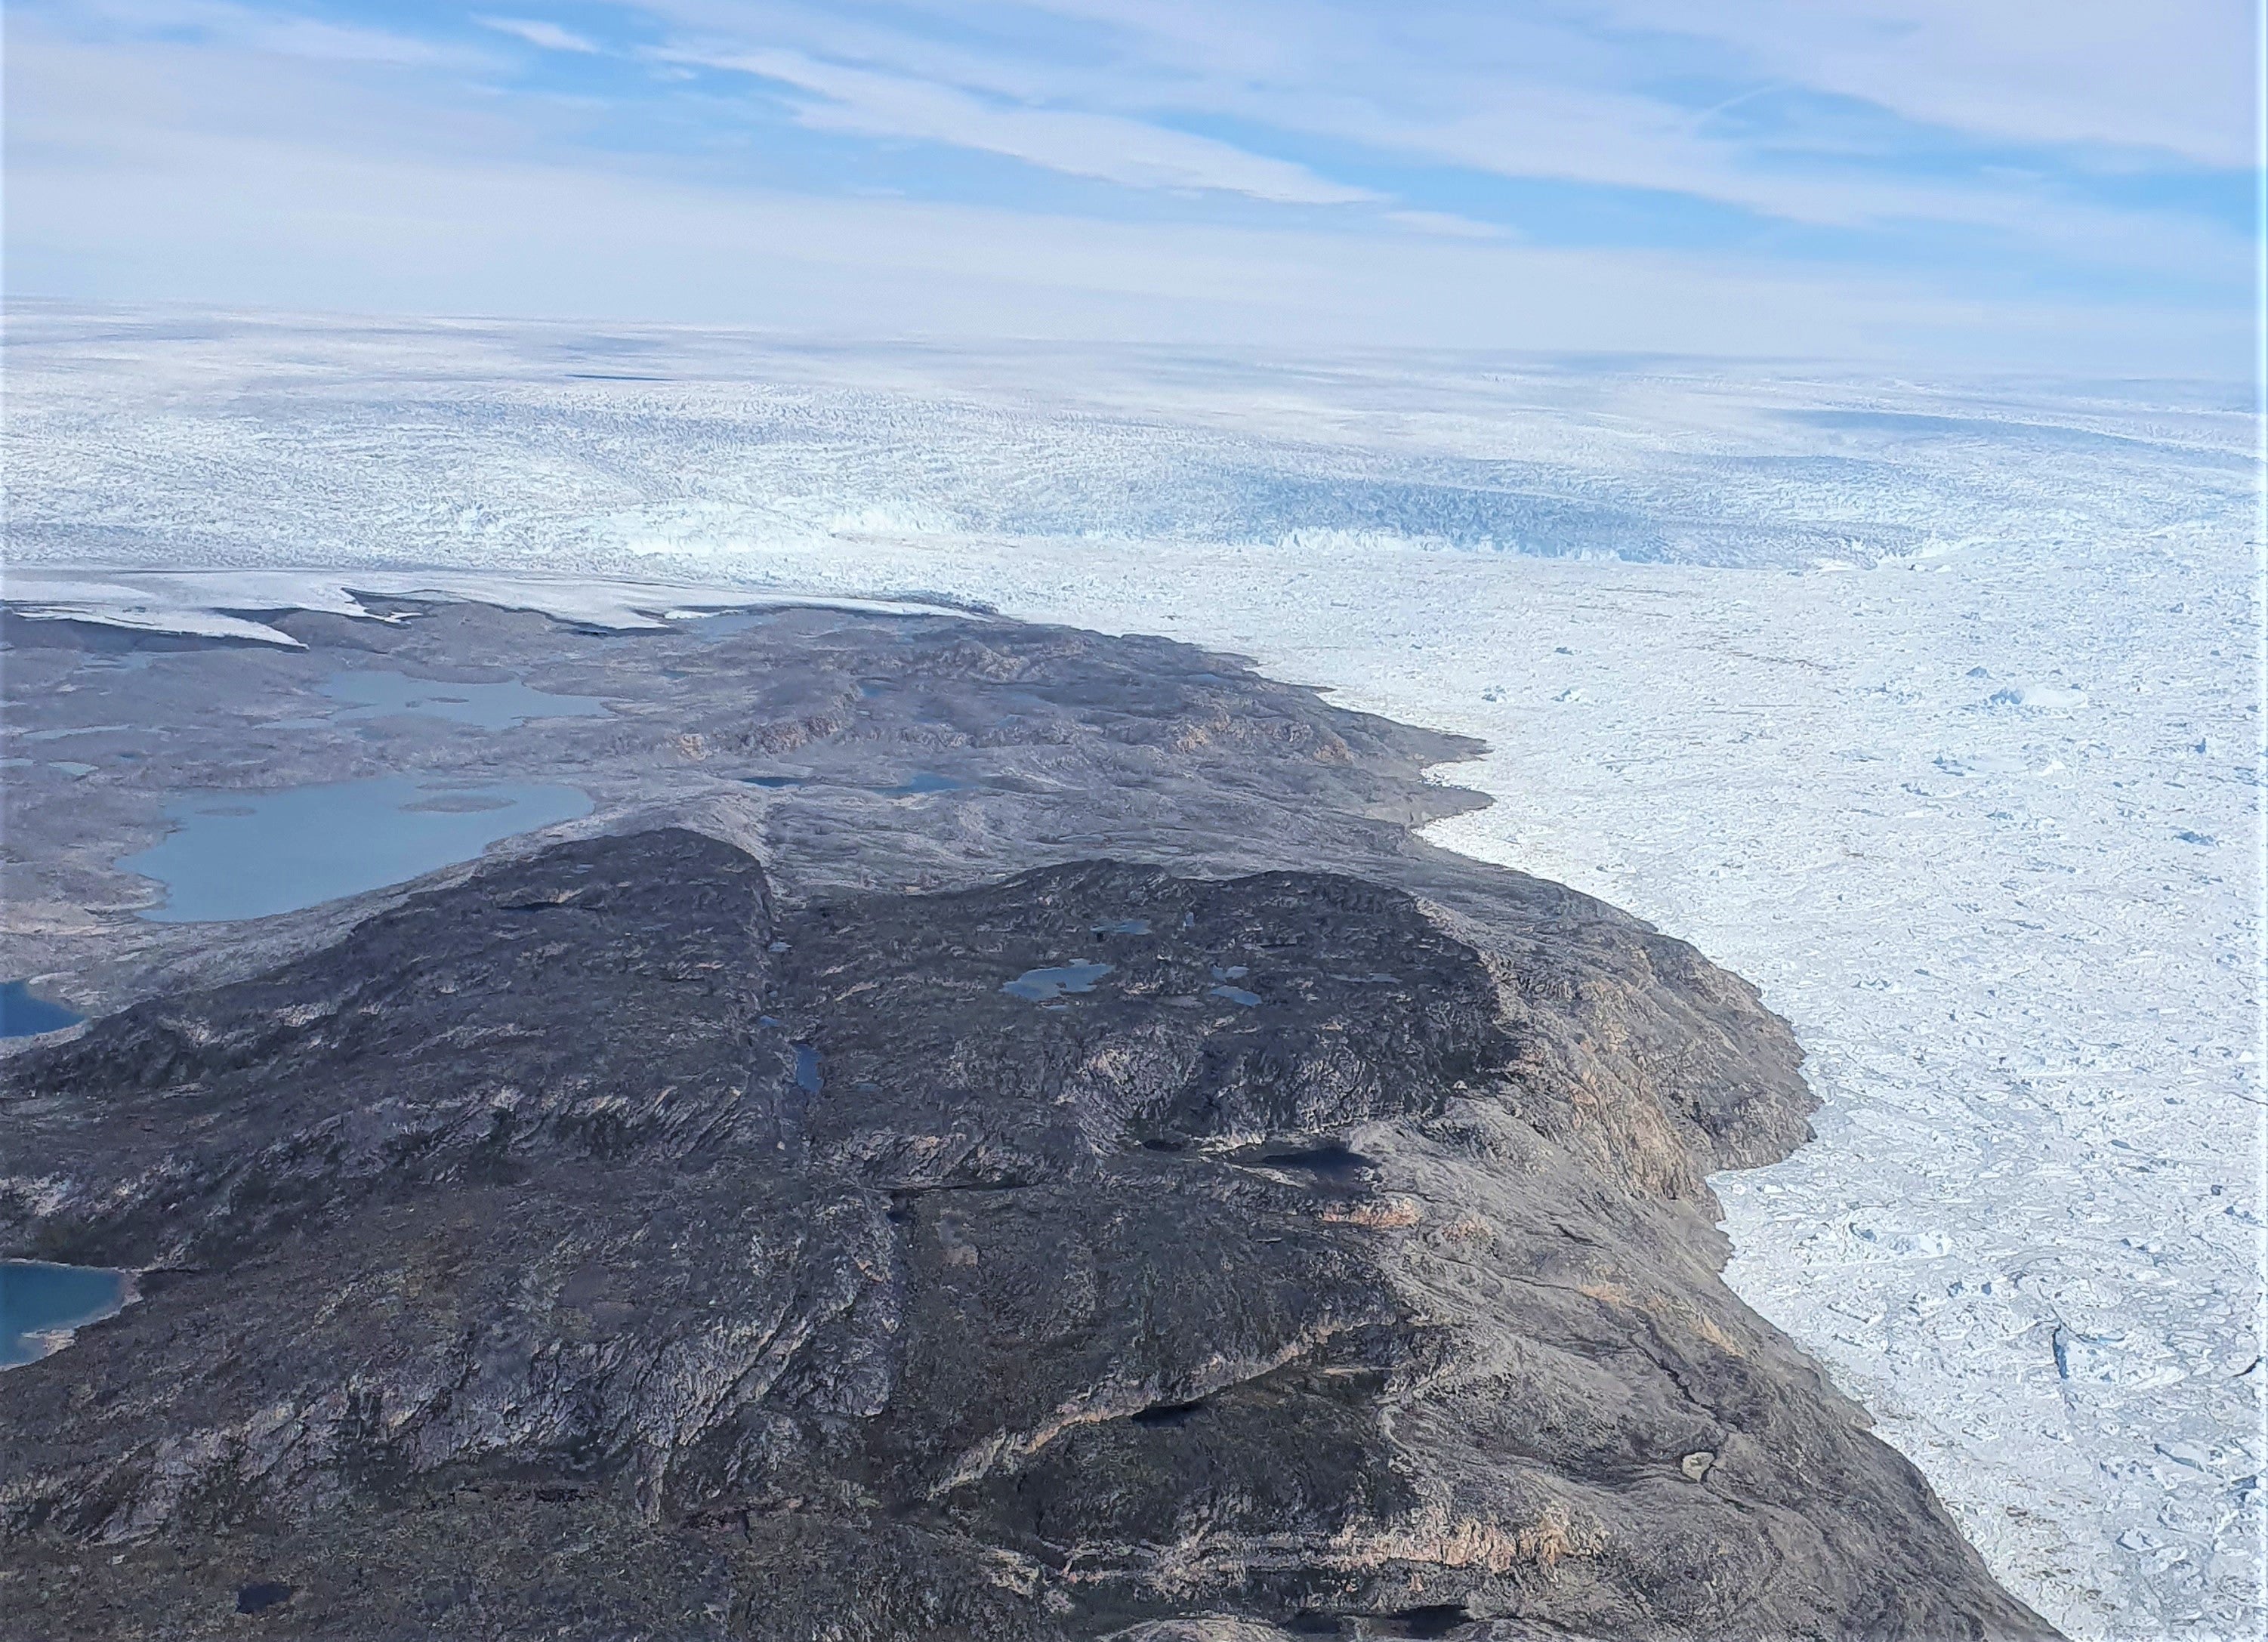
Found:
952,0 -> 2259,168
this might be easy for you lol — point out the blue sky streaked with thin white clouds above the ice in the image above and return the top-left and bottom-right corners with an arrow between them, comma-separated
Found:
5,0 -> 2259,378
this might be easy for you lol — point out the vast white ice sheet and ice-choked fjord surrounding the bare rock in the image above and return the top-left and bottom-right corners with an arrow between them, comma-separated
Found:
7,308 -> 2268,1637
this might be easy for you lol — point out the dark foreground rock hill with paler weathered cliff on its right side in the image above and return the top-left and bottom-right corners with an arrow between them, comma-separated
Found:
0,828 -> 2046,1642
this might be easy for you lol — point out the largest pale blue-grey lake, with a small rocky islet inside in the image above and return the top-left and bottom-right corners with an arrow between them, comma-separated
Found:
118,776 -> 592,923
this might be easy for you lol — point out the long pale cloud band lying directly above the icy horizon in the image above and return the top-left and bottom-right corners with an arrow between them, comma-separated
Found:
7,29 -> 2248,369
